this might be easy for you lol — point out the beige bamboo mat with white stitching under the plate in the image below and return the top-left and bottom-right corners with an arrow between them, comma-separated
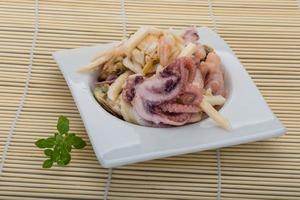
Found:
0,0 -> 300,200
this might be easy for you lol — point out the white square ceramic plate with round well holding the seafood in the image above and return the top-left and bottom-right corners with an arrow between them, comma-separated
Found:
54,27 -> 285,167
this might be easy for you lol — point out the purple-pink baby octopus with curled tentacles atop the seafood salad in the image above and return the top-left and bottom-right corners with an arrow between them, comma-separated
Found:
122,57 -> 202,126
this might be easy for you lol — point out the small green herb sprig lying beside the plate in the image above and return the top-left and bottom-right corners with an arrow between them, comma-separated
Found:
35,116 -> 86,168
